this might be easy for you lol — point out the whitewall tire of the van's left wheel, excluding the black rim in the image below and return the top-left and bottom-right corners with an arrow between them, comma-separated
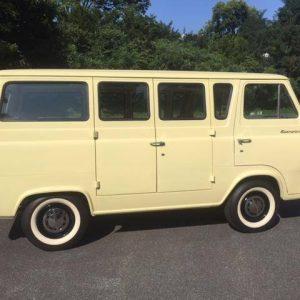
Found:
21,195 -> 91,251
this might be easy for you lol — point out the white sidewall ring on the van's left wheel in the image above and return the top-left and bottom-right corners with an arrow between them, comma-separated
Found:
30,198 -> 81,246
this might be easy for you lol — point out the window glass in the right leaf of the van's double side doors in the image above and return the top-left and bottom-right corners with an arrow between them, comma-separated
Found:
158,83 -> 206,120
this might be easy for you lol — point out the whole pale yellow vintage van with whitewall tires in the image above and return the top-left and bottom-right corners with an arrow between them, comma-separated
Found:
0,70 -> 300,250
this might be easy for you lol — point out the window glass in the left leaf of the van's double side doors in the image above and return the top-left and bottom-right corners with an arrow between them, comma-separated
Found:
98,82 -> 150,121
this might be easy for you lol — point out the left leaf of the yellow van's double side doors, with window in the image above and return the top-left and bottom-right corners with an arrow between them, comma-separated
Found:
94,78 -> 156,195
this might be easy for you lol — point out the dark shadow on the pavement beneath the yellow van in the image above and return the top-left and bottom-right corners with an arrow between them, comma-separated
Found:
10,200 -> 300,246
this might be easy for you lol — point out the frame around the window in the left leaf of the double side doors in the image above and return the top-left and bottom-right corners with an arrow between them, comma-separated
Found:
97,80 -> 151,122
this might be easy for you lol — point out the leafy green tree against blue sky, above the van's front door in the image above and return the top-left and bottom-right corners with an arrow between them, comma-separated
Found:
199,0 -> 273,72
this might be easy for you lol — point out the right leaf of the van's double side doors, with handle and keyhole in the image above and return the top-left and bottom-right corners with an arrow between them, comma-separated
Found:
154,79 -> 212,192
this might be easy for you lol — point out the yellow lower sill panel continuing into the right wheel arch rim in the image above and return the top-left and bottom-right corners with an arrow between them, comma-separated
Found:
90,166 -> 290,215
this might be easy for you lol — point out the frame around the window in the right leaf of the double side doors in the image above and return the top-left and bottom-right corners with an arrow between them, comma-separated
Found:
157,81 -> 208,122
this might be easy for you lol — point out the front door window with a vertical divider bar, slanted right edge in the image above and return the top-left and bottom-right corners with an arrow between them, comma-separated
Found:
244,84 -> 298,119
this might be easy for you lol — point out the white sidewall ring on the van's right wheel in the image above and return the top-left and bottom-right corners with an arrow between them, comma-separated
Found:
237,187 -> 276,228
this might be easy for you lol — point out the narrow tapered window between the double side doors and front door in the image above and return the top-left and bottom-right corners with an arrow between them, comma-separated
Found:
214,83 -> 233,120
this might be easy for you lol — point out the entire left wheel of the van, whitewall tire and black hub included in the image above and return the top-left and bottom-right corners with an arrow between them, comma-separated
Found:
21,196 -> 90,251
